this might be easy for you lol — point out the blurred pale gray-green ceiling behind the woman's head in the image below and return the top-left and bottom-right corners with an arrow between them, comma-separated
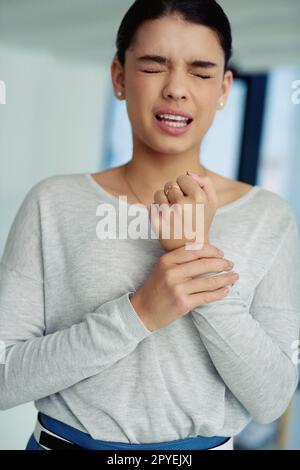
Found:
0,0 -> 300,72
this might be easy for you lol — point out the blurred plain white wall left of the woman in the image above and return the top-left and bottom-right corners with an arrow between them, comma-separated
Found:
0,46 -> 110,449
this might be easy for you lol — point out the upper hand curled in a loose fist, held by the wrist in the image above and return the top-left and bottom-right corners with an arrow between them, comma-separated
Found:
149,174 -> 218,251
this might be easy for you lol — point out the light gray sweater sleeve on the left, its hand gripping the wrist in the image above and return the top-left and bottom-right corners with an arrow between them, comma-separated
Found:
0,185 -> 152,410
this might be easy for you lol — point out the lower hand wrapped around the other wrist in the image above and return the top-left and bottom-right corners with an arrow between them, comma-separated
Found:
130,244 -> 238,331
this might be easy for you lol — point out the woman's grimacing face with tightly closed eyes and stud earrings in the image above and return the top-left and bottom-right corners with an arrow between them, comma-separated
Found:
111,15 -> 233,154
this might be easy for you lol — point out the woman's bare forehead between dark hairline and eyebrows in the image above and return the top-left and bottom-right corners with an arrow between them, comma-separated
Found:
128,15 -> 224,62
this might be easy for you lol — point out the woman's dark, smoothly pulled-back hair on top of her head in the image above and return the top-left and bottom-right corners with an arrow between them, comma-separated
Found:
115,0 -> 232,71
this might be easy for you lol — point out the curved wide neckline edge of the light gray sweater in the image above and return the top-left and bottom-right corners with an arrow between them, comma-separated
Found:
83,173 -> 262,216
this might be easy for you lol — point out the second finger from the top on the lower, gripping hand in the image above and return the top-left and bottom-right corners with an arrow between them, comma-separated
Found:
175,257 -> 232,279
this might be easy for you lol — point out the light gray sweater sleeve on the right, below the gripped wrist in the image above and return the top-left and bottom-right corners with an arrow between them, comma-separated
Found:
191,211 -> 300,424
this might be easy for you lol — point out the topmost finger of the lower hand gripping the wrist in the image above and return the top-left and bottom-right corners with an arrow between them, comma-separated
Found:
163,243 -> 224,265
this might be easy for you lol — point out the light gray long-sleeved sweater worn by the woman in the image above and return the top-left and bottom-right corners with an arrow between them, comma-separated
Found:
0,174 -> 300,443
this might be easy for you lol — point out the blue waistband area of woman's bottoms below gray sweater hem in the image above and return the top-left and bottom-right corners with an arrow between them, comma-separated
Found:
25,412 -> 230,450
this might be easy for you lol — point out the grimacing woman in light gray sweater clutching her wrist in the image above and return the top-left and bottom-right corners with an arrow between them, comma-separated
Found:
0,0 -> 300,450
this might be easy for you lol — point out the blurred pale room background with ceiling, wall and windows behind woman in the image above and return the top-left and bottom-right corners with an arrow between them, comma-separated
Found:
0,0 -> 300,450
